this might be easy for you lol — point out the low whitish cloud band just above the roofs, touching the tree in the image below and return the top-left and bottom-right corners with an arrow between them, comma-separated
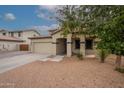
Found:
31,24 -> 59,35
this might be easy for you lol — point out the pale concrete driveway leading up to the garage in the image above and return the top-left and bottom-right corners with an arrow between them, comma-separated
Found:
0,51 -> 50,73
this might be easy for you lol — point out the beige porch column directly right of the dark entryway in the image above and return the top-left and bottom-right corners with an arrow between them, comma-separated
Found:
67,34 -> 72,57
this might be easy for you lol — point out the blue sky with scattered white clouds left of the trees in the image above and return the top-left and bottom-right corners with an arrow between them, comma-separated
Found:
0,5 -> 58,34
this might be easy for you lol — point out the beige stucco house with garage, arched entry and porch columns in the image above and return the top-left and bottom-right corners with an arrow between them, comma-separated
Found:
30,30 -> 98,57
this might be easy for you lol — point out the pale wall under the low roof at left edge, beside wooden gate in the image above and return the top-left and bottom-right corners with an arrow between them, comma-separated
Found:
0,41 -> 19,51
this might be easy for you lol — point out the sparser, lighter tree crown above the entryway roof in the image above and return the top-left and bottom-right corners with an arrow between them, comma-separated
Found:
56,5 -> 89,36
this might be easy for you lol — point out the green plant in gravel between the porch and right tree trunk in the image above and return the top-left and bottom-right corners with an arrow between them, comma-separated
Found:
98,49 -> 109,63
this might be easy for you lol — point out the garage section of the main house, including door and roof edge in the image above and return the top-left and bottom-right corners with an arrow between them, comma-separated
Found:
31,37 -> 52,54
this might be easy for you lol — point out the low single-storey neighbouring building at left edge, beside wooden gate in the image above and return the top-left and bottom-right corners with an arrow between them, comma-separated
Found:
0,36 -> 24,51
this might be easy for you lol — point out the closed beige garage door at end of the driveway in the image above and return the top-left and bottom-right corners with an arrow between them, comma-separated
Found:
34,43 -> 52,54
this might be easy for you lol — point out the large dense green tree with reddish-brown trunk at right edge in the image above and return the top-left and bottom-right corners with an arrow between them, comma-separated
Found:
79,6 -> 124,68
